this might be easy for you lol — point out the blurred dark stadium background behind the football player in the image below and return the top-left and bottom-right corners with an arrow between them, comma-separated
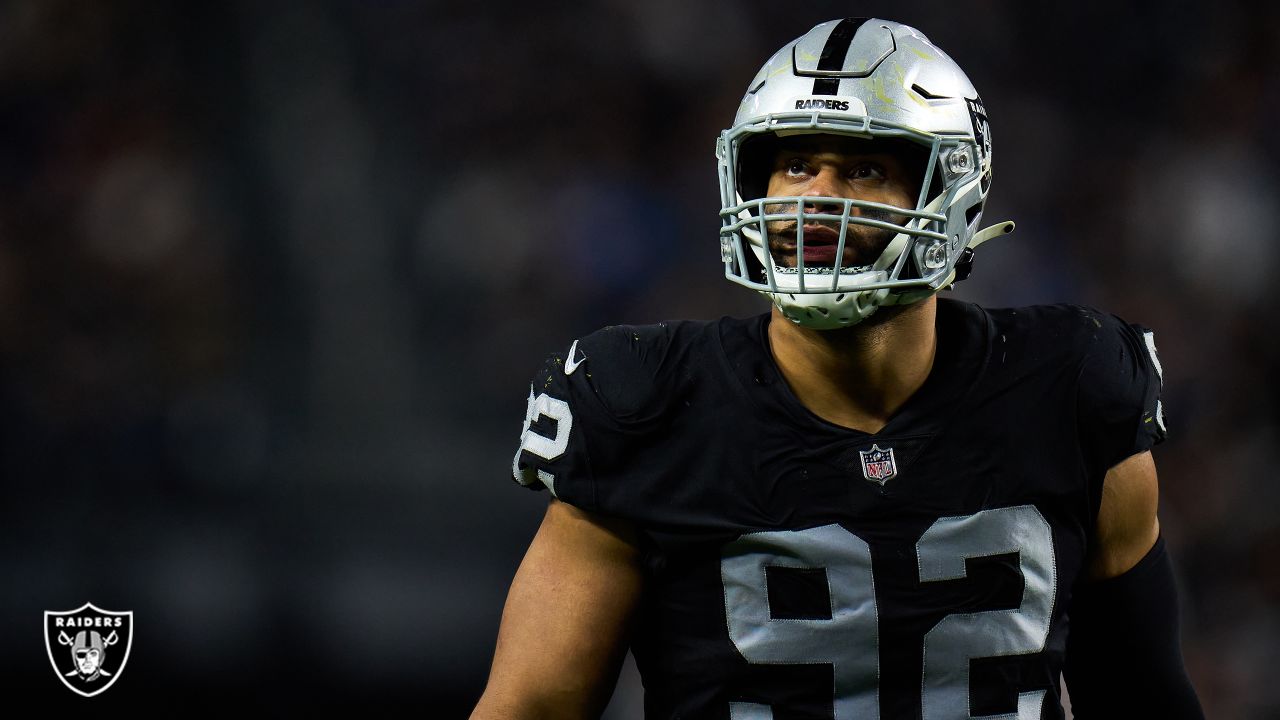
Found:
0,0 -> 1280,719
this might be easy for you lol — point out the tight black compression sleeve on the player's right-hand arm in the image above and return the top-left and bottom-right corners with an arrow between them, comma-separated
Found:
1064,538 -> 1204,720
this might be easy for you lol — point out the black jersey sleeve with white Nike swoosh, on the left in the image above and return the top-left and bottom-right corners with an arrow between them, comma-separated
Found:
512,319 -> 668,510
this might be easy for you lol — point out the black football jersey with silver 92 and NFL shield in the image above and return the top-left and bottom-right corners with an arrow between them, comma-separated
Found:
513,300 -> 1164,720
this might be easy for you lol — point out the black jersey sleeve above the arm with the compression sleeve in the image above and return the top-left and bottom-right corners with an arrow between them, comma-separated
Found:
1076,311 -> 1166,473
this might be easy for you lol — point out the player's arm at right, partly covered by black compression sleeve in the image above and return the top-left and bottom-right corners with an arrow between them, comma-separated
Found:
1066,451 -> 1204,720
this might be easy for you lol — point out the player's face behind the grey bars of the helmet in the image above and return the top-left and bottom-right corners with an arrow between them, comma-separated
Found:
765,135 -> 919,268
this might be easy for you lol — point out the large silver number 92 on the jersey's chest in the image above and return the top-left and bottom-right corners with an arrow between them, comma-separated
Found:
721,505 -> 1057,720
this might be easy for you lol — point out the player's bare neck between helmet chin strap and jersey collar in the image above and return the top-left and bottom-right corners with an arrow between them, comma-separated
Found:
769,297 -> 937,433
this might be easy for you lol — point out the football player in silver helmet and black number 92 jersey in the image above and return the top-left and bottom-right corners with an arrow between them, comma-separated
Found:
474,18 -> 1202,720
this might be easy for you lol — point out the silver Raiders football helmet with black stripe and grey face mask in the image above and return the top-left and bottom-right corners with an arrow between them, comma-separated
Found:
716,18 -> 1014,329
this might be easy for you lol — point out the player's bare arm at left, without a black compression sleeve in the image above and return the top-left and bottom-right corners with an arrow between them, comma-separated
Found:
471,500 -> 641,720
